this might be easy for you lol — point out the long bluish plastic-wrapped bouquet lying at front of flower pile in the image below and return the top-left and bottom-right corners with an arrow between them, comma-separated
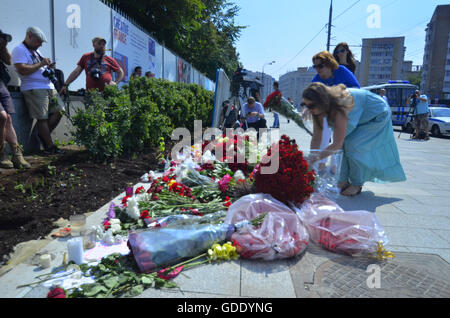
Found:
128,224 -> 234,273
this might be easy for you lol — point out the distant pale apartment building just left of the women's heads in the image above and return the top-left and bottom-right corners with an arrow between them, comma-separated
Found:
279,67 -> 317,108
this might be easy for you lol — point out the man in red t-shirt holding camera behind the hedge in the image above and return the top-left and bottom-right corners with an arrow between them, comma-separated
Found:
60,37 -> 124,94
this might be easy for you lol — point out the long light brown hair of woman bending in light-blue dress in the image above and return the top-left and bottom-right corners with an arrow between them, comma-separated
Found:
303,82 -> 355,128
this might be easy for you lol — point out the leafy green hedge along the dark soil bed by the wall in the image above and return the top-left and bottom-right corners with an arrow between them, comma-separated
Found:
73,77 -> 214,159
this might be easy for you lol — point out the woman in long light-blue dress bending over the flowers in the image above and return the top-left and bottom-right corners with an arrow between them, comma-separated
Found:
302,83 -> 406,196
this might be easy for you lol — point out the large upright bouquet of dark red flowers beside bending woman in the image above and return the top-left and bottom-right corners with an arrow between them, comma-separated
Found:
254,135 -> 315,204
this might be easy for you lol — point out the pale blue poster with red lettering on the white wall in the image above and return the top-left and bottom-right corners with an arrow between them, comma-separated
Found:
113,10 -> 157,83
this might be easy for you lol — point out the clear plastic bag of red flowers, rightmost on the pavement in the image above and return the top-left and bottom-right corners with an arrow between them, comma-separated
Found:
292,193 -> 388,256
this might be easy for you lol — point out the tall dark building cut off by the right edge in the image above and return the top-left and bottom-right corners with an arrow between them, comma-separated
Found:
421,5 -> 450,99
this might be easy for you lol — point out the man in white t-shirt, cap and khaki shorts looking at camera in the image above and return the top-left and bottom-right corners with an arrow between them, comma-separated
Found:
12,27 -> 64,155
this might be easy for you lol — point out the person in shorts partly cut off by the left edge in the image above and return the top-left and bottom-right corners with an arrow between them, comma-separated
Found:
0,30 -> 31,169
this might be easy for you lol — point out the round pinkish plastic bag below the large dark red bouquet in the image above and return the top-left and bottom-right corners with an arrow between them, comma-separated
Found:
225,194 -> 309,260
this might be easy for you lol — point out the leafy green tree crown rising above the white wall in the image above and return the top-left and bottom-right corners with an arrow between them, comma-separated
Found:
106,0 -> 245,79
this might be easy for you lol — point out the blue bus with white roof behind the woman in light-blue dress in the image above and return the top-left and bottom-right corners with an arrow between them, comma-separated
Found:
361,81 -> 418,125
